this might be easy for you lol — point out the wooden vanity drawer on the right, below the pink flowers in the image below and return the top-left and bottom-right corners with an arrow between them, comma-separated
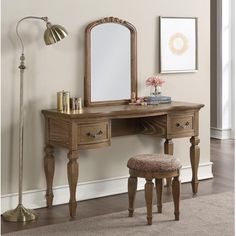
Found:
168,114 -> 194,137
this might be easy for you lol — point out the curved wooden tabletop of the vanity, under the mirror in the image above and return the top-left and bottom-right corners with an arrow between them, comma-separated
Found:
42,101 -> 204,119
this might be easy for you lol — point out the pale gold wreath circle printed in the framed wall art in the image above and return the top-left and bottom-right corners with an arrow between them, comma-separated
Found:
169,33 -> 188,55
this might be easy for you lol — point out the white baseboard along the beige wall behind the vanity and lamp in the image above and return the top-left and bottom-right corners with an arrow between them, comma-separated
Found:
1,162 -> 213,213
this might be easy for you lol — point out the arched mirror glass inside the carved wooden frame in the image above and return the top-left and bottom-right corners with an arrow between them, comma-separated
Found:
91,23 -> 131,102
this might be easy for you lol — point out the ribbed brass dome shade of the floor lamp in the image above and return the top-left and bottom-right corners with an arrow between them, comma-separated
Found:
44,24 -> 68,45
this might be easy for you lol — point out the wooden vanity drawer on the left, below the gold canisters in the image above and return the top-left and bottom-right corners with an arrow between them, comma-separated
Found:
78,121 -> 111,148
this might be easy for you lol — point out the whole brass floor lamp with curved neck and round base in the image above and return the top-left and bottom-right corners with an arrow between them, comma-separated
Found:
3,16 -> 68,222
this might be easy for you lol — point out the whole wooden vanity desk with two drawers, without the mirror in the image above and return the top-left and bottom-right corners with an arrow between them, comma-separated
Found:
42,102 -> 204,217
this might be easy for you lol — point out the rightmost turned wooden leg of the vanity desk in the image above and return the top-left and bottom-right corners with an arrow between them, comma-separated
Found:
190,136 -> 200,194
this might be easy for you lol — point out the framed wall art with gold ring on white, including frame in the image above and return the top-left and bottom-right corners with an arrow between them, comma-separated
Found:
159,17 -> 198,73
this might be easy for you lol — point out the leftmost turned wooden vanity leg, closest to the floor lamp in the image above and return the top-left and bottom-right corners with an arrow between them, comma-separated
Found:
44,145 -> 55,207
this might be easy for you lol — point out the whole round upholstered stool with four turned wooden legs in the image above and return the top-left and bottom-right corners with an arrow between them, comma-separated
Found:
127,154 -> 182,225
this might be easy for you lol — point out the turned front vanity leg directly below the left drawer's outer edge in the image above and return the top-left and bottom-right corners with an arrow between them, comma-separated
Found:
67,150 -> 79,217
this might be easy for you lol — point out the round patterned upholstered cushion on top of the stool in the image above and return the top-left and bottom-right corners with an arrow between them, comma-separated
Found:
127,154 -> 182,172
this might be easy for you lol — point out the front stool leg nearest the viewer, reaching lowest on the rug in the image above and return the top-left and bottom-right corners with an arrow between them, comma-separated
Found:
145,179 -> 154,225
